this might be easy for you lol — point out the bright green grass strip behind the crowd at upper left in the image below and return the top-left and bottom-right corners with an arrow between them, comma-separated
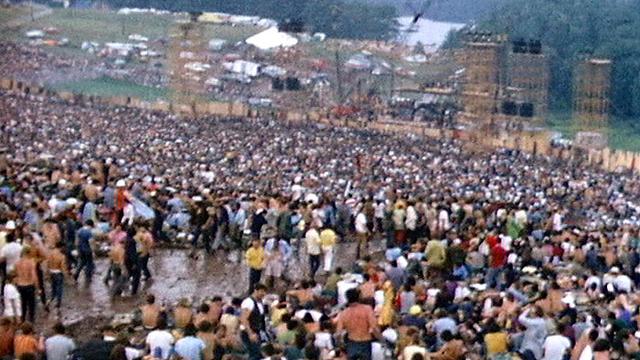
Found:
51,77 -> 169,101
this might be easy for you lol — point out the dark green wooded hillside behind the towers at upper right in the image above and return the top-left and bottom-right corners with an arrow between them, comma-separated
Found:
452,0 -> 640,118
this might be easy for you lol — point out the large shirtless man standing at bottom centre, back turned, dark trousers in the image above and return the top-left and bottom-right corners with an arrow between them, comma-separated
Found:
337,289 -> 380,360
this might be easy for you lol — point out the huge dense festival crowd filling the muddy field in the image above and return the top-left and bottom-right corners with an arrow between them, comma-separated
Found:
0,86 -> 640,360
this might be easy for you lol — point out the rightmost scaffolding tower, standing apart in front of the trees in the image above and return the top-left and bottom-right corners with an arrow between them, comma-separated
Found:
573,59 -> 611,131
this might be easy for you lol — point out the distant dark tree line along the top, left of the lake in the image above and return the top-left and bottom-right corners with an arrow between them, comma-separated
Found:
100,0 -> 397,39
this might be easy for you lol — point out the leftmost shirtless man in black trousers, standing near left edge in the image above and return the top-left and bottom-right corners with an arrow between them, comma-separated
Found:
15,247 -> 38,323
